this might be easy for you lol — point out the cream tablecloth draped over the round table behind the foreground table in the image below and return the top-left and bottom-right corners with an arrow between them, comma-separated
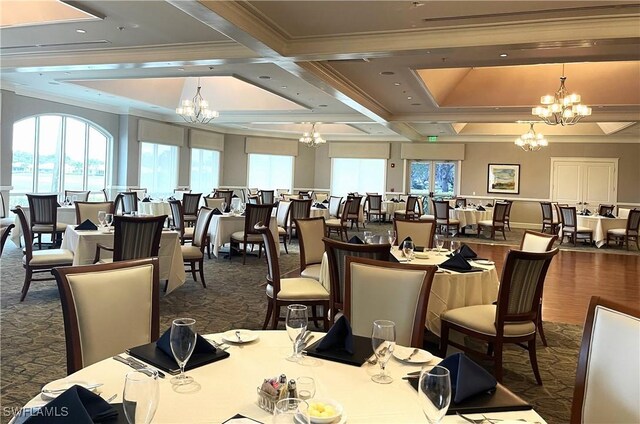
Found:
320,247 -> 500,336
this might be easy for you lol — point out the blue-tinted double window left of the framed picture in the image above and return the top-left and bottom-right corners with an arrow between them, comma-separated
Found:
409,161 -> 458,197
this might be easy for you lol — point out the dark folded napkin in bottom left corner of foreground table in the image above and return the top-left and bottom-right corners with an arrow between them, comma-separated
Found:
24,385 -> 118,424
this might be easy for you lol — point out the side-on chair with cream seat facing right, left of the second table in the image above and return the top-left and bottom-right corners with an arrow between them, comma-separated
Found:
254,223 -> 329,331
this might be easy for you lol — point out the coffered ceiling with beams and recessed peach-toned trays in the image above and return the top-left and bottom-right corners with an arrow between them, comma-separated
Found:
0,0 -> 640,143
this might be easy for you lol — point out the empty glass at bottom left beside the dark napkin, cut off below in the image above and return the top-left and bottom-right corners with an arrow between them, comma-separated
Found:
122,368 -> 160,424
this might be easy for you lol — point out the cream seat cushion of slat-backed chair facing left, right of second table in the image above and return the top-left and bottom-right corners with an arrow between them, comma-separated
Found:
440,305 -> 536,337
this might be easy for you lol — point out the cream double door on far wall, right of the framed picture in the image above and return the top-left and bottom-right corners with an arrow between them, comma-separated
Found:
551,158 -> 618,206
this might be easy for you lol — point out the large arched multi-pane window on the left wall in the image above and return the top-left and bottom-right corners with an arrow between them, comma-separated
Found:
10,115 -> 111,205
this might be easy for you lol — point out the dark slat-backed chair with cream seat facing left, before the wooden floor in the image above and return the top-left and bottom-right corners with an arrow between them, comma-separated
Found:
440,248 -> 558,385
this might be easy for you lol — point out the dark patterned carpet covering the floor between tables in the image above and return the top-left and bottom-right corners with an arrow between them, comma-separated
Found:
0,224 -> 582,423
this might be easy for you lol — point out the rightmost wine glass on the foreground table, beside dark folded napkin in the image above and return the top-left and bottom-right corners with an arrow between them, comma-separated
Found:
418,365 -> 451,424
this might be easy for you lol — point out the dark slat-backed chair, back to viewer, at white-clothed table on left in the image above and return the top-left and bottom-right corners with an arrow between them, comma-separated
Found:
94,215 -> 167,263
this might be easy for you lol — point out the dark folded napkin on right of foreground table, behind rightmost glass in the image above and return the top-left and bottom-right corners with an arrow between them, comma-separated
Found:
438,353 -> 497,403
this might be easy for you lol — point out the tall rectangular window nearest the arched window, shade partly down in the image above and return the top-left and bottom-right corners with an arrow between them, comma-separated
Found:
140,142 -> 178,198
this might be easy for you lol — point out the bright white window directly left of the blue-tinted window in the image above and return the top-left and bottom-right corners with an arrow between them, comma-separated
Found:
331,158 -> 387,197
